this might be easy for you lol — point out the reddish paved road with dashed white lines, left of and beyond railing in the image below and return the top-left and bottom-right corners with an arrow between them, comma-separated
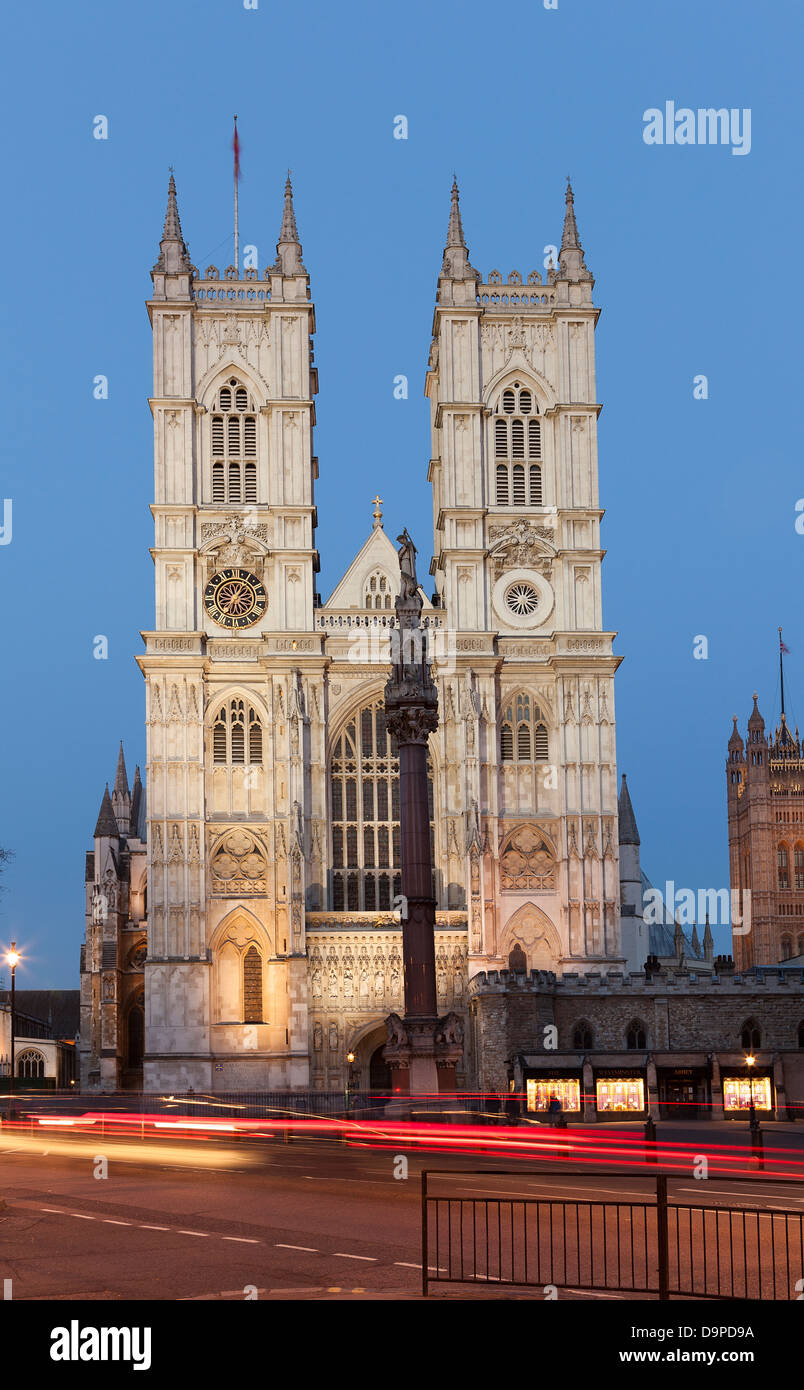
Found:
0,1130 -> 804,1300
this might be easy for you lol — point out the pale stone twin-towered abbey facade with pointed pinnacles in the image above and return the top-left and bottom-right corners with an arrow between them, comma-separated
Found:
81,175 -> 633,1091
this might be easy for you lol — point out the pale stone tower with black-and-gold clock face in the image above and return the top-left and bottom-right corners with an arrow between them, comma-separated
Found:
139,174 -> 317,1090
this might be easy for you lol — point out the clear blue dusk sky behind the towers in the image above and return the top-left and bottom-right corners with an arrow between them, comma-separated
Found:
0,0 -> 804,988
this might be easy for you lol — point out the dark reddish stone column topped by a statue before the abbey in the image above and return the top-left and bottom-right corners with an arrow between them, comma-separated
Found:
385,531 -> 463,1094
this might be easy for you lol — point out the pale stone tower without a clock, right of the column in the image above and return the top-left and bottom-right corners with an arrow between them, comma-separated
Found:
426,181 -> 620,973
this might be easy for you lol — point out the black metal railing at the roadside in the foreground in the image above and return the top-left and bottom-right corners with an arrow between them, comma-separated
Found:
421,1170 -> 804,1300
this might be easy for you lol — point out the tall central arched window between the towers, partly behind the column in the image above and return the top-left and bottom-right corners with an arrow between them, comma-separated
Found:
330,699 -> 433,912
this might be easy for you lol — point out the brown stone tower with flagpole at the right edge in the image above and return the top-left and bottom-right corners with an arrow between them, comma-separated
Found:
726,695 -> 804,970
